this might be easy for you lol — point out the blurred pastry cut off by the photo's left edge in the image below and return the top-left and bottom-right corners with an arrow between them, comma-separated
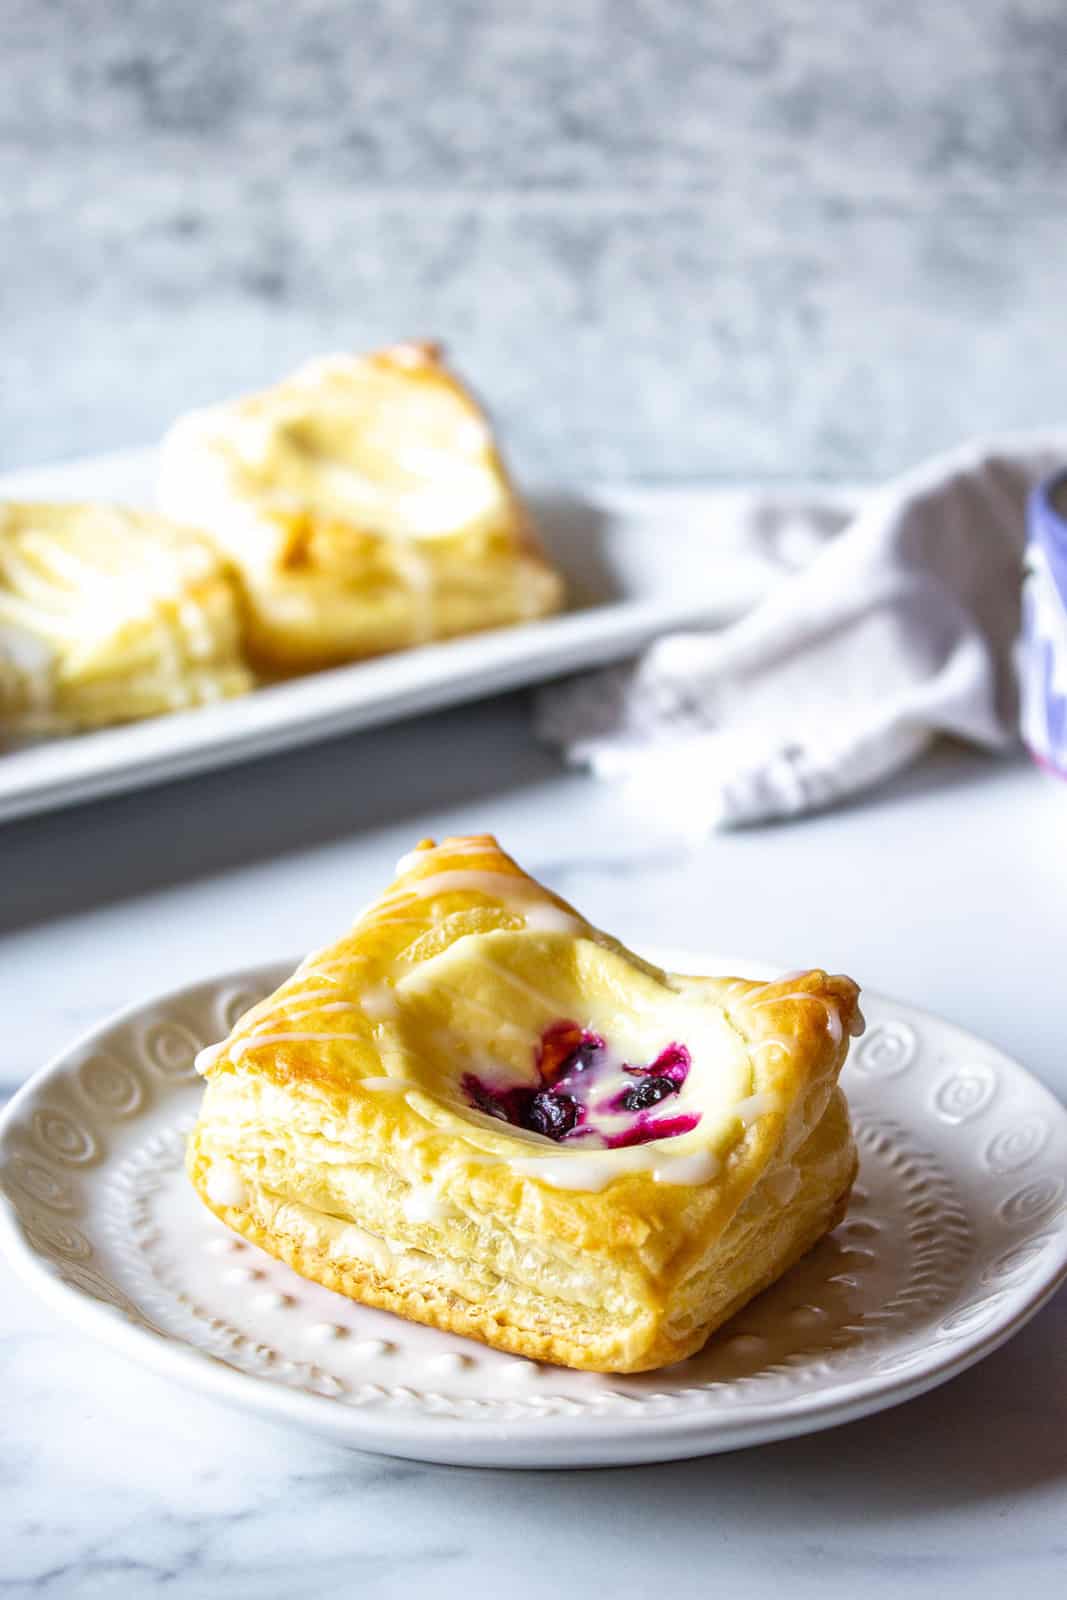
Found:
0,502 -> 253,734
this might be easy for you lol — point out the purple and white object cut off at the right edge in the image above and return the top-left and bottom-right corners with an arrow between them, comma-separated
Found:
1019,472 -> 1067,778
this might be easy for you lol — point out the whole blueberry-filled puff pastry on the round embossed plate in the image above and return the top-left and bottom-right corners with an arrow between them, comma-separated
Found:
189,835 -> 862,1373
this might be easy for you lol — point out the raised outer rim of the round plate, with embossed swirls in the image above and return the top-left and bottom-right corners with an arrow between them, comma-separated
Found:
0,949 -> 1067,1467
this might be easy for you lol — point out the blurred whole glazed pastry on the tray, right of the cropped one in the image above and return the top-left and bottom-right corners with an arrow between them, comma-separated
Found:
160,344 -> 563,672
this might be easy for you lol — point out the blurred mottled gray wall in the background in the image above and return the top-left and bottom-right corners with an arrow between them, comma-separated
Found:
0,0 -> 1067,480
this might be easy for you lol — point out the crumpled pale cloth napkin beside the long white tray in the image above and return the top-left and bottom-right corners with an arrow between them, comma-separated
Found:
536,430 -> 1067,832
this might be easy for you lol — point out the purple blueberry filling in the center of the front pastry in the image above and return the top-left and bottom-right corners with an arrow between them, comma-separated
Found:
462,1021 -> 701,1149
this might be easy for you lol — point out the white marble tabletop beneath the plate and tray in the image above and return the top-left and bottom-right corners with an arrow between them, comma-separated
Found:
0,699 -> 1067,1600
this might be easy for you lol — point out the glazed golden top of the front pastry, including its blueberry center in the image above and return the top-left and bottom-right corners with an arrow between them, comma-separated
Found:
198,835 -> 861,1194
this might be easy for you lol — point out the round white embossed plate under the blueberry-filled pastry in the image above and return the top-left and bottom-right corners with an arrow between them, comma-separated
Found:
0,950 -> 1067,1467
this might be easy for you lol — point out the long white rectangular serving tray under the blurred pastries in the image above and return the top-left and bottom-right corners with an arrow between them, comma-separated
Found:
0,451 -> 819,821
